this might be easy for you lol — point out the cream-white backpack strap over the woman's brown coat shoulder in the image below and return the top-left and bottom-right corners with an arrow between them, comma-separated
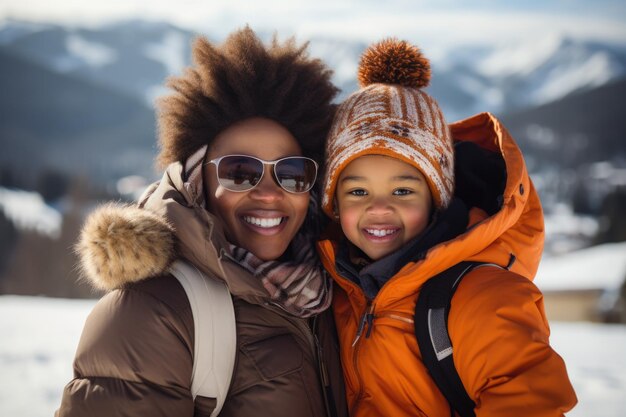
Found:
170,260 -> 237,417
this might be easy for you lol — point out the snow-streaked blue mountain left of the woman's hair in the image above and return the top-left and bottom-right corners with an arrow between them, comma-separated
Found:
0,20 -> 193,104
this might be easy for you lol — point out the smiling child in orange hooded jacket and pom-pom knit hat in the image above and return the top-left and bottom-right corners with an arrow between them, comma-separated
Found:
319,40 -> 576,417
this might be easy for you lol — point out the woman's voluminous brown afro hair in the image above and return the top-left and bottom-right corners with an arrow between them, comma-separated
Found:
158,26 -> 338,166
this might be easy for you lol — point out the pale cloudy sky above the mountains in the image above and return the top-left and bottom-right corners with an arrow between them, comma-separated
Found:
0,0 -> 626,44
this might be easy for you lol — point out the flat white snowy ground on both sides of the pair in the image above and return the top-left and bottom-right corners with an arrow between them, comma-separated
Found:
0,296 -> 626,417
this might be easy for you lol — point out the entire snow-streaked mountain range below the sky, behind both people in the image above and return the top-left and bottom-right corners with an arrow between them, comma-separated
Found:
0,20 -> 626,120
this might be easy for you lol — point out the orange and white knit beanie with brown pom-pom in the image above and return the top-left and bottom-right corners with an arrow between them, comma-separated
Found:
322,39 -> 454,217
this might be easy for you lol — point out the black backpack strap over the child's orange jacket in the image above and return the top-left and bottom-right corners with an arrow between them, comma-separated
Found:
415,262 -> 480,417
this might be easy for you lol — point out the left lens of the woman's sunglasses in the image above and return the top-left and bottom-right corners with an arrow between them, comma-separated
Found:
217,156 -> 263,191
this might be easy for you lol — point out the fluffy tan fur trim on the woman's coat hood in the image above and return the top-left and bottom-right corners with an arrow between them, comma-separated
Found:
75,204 -> 176,291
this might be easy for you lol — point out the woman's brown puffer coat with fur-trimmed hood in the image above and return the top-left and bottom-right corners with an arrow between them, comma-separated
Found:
57,164 -> 346,417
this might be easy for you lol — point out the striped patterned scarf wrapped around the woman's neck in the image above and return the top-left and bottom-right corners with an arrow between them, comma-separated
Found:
185,146 -> 332,318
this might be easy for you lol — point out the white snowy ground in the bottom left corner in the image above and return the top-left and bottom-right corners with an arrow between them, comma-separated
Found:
0,296 -> 94,417
